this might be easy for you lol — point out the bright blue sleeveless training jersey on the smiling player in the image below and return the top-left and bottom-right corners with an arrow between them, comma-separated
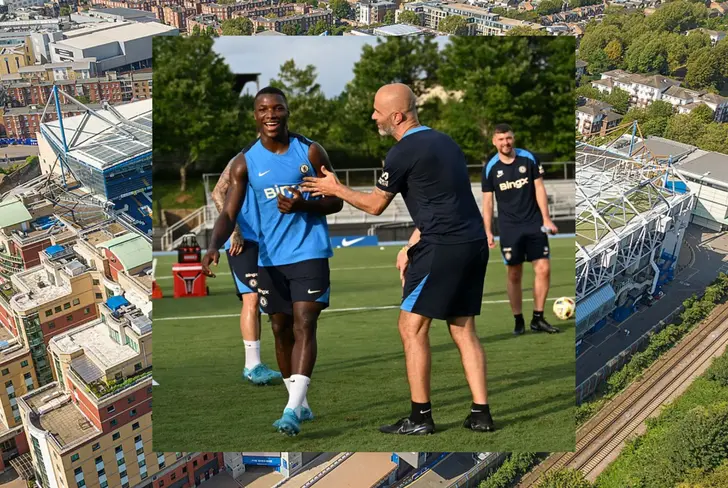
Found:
243,133 -> 334,266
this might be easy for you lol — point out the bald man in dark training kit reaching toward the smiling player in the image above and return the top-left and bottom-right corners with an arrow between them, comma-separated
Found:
301,83 -> 494,435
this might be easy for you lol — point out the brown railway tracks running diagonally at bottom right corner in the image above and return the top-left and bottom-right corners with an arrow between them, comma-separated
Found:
518,304 -> 728,488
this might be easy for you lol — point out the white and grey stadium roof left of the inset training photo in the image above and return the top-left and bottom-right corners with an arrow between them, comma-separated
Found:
41,99 -> 152,170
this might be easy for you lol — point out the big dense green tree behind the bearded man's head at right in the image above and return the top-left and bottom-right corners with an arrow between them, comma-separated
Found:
438,36 -> 576,161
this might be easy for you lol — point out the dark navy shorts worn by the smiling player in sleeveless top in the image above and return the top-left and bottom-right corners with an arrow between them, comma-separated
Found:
258,258 -> 331,315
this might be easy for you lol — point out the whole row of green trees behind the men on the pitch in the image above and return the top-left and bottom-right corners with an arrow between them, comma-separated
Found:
153,36 -> 575,187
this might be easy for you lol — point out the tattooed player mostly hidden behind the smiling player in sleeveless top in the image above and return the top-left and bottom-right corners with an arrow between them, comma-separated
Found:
212,161 -> 281,385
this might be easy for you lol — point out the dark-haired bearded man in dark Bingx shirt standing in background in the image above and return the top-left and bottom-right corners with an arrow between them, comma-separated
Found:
482,124 -> 559,334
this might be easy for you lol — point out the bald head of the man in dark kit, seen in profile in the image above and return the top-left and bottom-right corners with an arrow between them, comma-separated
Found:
372,83 -> 420,140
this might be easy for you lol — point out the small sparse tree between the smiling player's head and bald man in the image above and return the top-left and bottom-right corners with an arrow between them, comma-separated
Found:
271,59 -> 334,140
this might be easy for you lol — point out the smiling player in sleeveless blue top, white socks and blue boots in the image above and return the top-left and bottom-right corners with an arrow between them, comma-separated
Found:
202,87 -> 343,435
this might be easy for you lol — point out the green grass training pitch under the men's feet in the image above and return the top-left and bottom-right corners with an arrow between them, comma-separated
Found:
154,239 -> 575,452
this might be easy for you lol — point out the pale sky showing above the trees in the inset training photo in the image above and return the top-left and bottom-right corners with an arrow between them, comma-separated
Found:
213,36 -> 447,98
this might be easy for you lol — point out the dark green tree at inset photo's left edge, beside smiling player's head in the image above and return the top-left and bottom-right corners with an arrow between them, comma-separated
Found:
153,36 -> 246,192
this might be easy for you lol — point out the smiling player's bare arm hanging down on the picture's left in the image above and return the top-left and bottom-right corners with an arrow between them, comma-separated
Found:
202,153 -> 248,276
